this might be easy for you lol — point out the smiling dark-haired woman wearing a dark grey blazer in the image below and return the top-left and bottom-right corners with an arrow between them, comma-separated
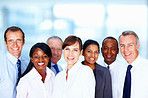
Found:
82,40 -> 112,98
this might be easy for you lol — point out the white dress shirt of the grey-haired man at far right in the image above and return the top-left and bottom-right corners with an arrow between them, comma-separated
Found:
119,56 -> 148,98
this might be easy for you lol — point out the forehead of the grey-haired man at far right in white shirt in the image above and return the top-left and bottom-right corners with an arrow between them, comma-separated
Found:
119,35 -> 136,44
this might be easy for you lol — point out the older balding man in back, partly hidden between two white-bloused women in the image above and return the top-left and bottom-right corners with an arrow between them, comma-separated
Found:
47,36 -> 63,75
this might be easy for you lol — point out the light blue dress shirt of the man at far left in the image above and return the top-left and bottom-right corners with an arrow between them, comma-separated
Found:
0,52 -> 28,98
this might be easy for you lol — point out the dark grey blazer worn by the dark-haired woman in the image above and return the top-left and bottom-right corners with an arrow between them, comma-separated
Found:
93,63 -> 112,98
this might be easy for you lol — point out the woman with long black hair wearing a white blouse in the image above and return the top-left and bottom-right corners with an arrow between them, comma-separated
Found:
17,43 -> 55,98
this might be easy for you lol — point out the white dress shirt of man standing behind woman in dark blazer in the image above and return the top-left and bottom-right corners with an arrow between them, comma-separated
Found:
99,59 -> 126,98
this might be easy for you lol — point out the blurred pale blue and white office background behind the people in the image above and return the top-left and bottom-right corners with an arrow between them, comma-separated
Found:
0,0 -> 148,62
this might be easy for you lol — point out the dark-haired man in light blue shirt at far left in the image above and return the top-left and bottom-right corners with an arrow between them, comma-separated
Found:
0,26 -> 28,98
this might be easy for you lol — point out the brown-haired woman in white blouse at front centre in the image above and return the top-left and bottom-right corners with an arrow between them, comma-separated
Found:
52,36 -> 95,98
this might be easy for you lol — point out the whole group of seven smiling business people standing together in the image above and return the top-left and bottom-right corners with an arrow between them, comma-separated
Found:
0,26 -> 148,98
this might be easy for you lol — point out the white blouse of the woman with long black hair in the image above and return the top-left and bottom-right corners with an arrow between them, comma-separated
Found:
16,67 -> 55,98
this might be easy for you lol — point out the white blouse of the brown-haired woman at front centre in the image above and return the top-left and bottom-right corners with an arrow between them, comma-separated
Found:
52,62 -> 95,98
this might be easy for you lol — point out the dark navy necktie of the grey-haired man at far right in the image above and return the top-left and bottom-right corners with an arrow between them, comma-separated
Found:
123,65 -> 132,98
